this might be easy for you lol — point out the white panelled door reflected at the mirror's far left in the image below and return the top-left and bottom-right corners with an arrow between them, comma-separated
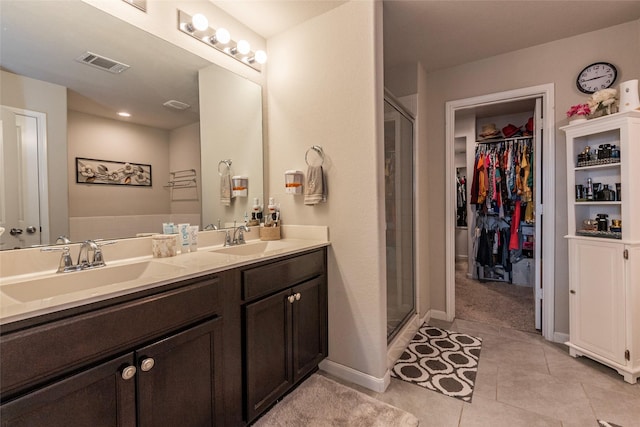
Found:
0,106 -> 43,249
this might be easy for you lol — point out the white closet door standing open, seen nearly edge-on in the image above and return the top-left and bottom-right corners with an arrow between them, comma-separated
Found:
533,98 -> 552,330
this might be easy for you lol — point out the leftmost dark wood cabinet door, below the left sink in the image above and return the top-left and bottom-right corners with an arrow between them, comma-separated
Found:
0,354 -> 136,427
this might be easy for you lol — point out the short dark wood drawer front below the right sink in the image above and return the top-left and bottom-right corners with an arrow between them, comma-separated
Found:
242,249 -> 326,300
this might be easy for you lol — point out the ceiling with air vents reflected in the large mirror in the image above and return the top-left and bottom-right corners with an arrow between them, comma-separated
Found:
0,0 -> 206,130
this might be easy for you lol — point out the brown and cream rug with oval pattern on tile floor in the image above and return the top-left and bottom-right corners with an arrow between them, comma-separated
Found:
391,324 -> 482,402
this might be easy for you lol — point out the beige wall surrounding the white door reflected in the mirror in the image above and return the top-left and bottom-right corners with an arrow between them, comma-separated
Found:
0,71 -> 69,241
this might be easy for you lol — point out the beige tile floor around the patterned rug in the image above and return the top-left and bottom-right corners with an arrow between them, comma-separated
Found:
328,319 -> 640,427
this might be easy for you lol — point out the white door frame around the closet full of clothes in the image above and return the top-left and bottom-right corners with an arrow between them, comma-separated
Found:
445,83 -> 555,340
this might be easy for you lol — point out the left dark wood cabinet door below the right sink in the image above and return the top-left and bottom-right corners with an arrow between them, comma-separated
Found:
245,289 -> 293,421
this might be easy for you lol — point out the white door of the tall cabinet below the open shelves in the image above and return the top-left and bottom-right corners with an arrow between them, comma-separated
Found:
569,239 -> 625,365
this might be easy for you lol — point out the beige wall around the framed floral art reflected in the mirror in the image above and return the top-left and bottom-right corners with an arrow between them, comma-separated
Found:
67,111 -> 170,217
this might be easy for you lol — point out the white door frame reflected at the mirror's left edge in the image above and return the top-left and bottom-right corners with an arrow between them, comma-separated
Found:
0,105 -> 50,245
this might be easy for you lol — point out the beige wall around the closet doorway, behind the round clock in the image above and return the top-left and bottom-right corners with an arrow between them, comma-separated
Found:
419,21 -> 640,333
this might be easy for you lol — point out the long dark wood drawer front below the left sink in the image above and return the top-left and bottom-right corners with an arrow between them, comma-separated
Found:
0,278 -> 220,400
